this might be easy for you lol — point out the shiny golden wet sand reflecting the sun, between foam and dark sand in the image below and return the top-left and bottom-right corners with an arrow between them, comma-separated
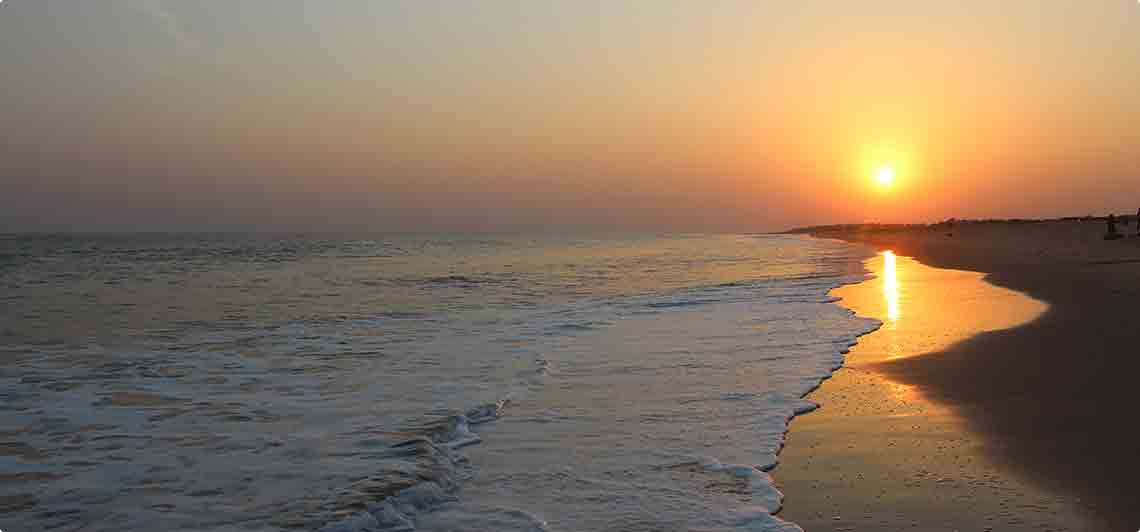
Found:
774,236 -> 1099,531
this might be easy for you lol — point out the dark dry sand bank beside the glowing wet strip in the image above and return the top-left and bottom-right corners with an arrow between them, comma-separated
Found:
789,221 -> 1140,530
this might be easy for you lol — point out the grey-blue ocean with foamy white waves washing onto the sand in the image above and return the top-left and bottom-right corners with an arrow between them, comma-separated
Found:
0,234 -> 879,532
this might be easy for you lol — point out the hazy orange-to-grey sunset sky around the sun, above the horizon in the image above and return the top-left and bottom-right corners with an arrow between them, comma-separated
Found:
0,0 -> 1140,231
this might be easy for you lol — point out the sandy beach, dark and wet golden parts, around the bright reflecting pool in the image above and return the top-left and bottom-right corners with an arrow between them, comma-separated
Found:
776,220 -> 1140,530
